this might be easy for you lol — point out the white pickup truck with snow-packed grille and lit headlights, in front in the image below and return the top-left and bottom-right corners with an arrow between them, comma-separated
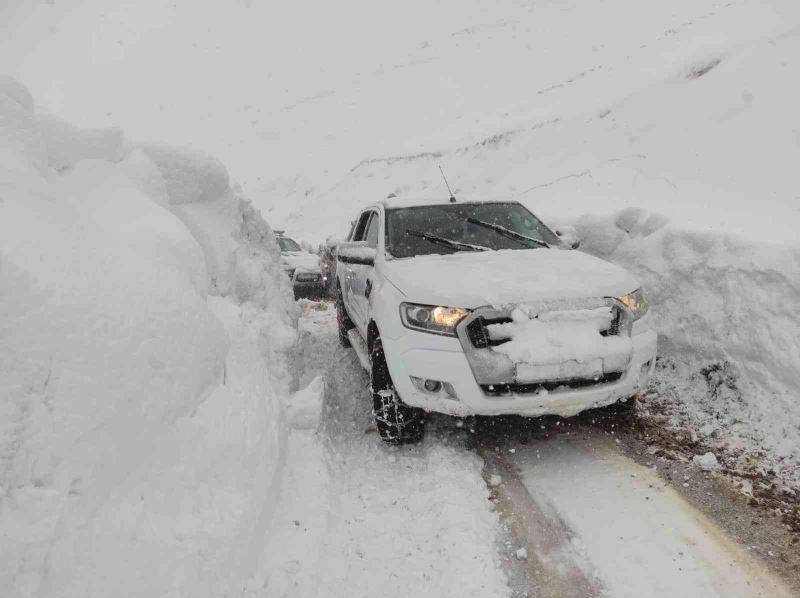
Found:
336,198 -> 656,443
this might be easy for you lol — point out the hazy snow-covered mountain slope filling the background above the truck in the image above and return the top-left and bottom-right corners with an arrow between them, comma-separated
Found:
0,0 -> 800,246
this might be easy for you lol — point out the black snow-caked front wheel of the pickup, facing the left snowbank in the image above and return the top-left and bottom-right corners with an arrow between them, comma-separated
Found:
370,338 -> 425,444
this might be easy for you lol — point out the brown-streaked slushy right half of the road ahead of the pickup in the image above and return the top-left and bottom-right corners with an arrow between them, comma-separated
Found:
477,418 -> 794,597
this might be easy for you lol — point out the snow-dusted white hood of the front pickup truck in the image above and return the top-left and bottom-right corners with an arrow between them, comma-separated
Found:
383,249 -> 638,308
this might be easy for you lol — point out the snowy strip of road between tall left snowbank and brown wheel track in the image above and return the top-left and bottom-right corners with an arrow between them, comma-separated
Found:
256,304 -> 510,598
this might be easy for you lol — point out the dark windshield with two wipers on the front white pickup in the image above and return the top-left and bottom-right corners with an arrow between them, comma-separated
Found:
386,202 -> 560,257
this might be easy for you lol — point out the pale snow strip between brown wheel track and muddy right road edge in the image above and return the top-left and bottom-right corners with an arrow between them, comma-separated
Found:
510,435 -> 791,598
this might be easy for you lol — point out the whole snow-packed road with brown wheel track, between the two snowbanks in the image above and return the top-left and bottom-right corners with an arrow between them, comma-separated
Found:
276,303 -> 794,597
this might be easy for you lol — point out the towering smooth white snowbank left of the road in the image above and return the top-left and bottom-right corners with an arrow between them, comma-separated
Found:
0,79 -> 296,596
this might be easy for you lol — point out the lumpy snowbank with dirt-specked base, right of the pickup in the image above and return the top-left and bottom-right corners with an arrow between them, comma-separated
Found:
575,210 -> 800,488
